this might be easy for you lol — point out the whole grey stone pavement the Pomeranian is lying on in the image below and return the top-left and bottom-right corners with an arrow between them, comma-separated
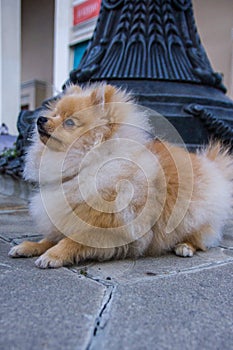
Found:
0,191 -> 233,350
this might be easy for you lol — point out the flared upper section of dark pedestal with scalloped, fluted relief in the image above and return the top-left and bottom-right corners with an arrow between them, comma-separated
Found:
70,0 -> 226,92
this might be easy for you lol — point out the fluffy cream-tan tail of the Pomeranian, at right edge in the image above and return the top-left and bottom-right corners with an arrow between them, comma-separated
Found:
204,142 -> 233,182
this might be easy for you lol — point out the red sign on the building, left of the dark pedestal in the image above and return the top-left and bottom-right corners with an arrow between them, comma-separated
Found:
73,0 -> 101,26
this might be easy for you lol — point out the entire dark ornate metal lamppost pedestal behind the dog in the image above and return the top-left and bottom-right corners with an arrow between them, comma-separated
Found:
0,0 -> 233,173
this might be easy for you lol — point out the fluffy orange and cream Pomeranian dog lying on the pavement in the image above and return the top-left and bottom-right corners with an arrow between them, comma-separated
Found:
9,84 -> 233,268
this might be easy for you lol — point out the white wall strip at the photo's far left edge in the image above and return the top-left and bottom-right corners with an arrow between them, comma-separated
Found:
0,0 -> 21,135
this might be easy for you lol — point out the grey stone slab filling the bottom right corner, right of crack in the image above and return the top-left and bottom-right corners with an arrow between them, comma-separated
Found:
90,263 -> 233,350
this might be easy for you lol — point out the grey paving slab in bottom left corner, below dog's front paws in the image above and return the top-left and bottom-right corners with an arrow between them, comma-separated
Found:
0,240 -> 106,350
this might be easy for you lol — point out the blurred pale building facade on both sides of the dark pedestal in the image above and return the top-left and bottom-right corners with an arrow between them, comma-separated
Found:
0,0 -> 233,134
